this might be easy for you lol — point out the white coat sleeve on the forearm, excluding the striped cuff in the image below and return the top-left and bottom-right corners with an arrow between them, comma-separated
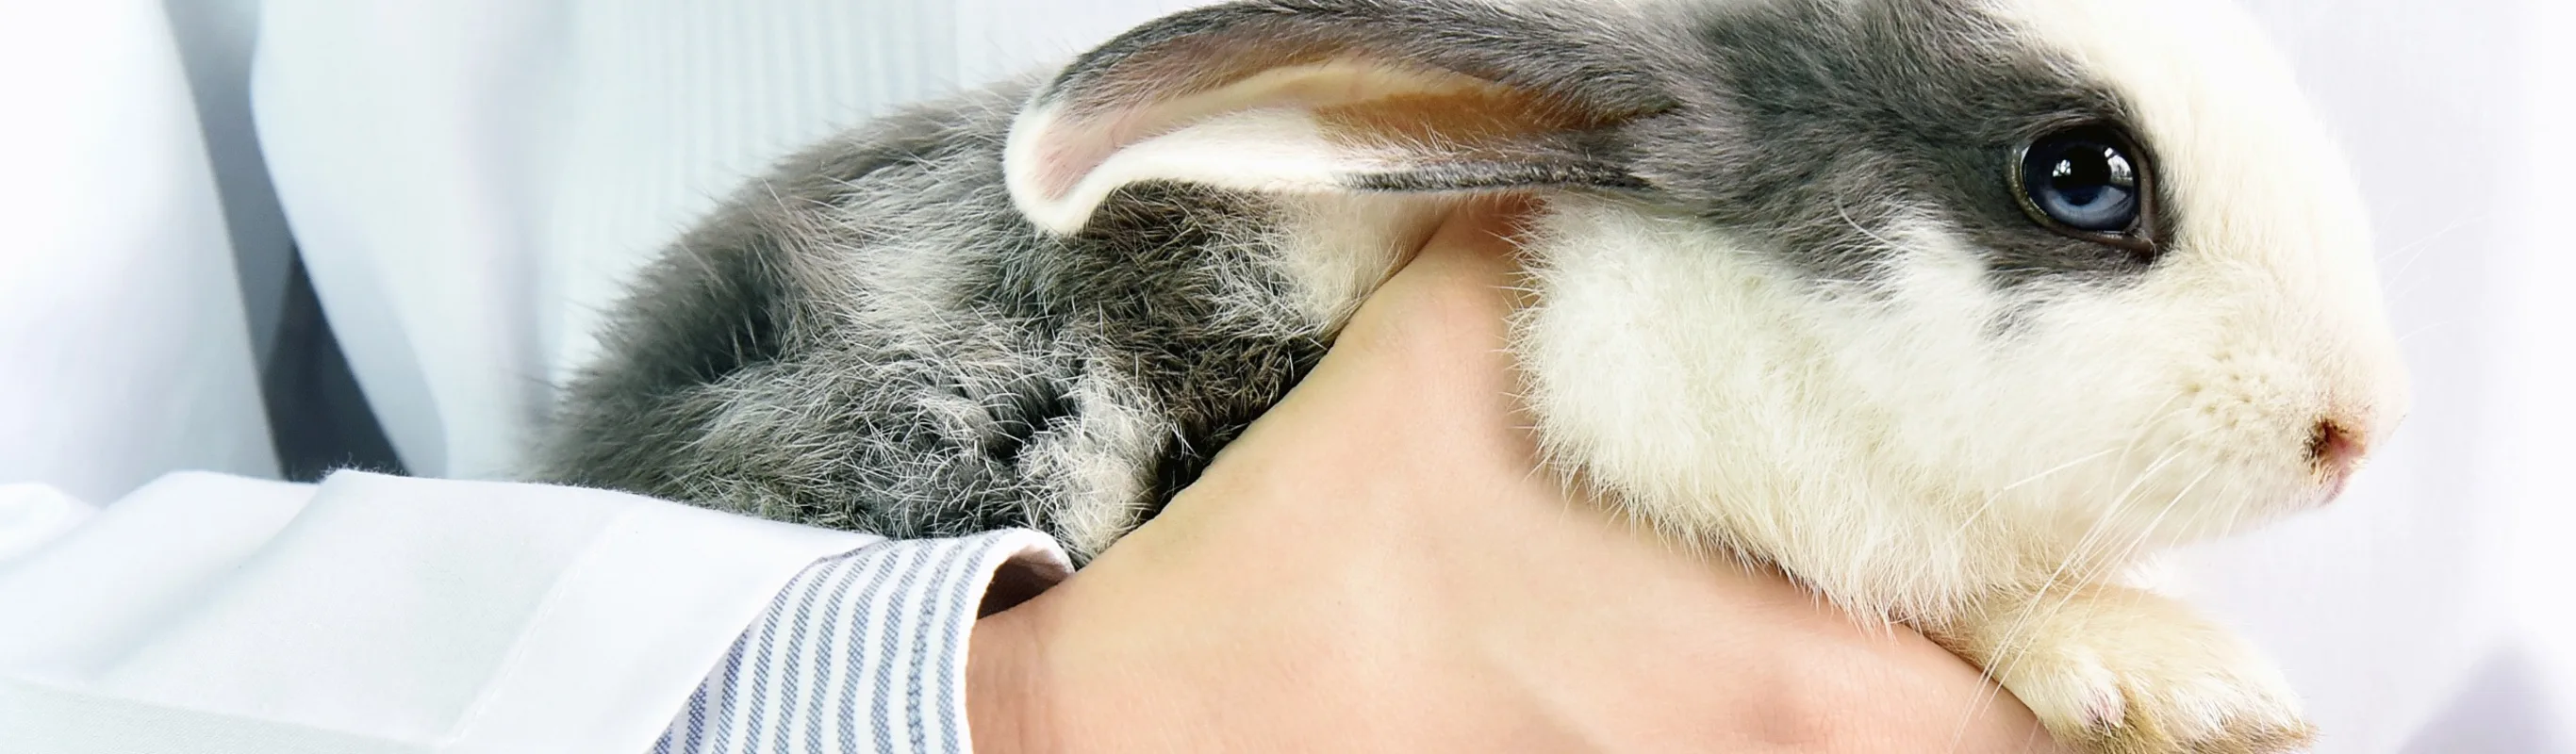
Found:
0,473 -> 876,754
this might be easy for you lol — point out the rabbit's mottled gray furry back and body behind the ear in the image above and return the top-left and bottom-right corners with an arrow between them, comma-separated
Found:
538,88 -> 1329,553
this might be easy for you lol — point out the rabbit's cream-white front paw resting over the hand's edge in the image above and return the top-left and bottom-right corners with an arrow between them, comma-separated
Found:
1945,587 -> 2316,754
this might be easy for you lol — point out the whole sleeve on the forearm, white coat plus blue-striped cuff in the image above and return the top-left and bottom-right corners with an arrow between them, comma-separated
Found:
0,473 -> 1064,754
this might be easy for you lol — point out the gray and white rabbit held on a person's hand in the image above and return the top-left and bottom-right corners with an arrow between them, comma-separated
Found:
536,0 -> 2408,751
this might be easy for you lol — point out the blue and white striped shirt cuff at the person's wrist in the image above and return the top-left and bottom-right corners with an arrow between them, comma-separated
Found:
654,530 -> 1064,754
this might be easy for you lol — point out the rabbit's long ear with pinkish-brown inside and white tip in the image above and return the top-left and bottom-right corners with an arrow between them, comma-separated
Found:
1004,0 -> 1672,234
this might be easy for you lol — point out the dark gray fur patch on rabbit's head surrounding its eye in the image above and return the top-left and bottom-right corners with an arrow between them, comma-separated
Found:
1630,0 -> 2171,286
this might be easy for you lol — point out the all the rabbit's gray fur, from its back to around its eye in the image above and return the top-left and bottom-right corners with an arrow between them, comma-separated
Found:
538,0 -> 2171,556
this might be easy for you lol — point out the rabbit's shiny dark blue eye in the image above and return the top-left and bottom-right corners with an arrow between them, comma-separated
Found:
2012,126 -> 2154,253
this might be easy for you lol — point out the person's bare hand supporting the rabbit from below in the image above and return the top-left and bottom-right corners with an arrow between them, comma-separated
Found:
968,198 -> 2056,754
